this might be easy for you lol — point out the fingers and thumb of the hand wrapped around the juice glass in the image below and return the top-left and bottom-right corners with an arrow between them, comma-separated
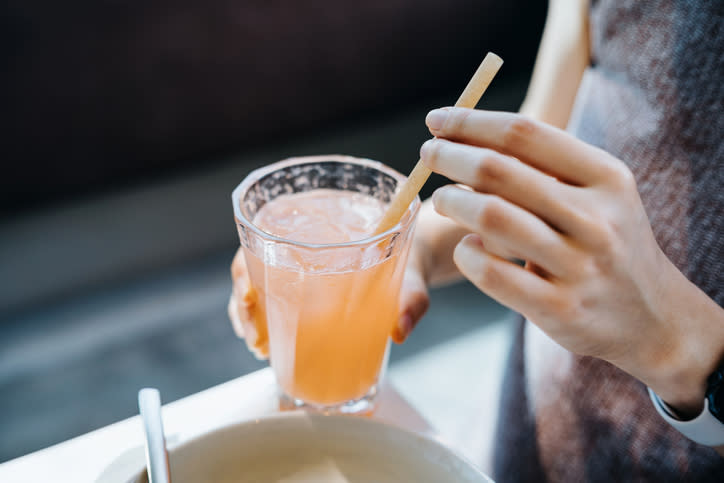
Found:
228,240 -> 429,359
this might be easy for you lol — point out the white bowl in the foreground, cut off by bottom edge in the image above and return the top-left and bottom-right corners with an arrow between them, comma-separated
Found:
132,412 -> 492,483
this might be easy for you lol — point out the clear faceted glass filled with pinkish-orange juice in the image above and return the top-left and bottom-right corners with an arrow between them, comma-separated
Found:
232,155 -> 420,413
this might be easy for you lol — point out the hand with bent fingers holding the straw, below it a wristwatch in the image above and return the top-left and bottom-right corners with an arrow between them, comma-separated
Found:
420,108 -> 724,416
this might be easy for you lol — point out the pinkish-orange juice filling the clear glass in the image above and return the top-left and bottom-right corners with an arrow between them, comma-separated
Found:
245,189 -> 410,406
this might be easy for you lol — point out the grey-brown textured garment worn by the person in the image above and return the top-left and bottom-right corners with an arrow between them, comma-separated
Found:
494,0 -> 724,482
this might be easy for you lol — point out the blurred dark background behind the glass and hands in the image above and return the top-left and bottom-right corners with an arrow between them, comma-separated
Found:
0,0 -> 546,462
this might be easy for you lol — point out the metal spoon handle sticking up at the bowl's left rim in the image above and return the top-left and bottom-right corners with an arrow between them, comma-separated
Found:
138,387 -> 171,483
